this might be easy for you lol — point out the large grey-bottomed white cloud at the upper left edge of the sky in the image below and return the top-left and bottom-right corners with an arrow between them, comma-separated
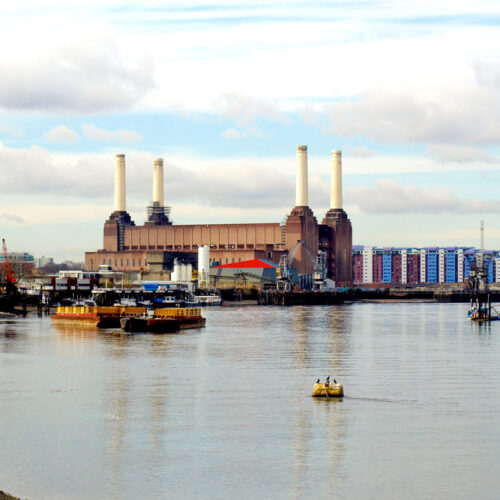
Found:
0,36 -> 153,113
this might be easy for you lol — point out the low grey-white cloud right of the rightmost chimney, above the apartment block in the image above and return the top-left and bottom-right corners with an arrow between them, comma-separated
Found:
346,179 -> 500,214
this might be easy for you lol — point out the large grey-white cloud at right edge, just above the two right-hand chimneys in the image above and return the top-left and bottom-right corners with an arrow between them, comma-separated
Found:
327,76 -> 500,145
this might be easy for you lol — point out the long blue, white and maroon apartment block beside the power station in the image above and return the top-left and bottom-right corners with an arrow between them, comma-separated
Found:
352,245 -> 500,285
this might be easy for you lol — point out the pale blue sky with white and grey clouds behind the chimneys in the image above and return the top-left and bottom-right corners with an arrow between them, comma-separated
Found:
0,0 -> 500,261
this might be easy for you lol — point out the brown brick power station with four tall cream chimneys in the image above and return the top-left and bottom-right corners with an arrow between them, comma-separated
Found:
85,146 -> 352,286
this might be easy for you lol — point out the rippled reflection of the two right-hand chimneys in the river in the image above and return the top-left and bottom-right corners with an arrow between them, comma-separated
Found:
290,306 -> 352,492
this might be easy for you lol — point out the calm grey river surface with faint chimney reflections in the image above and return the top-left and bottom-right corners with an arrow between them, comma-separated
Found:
0,303 -> 500,500
